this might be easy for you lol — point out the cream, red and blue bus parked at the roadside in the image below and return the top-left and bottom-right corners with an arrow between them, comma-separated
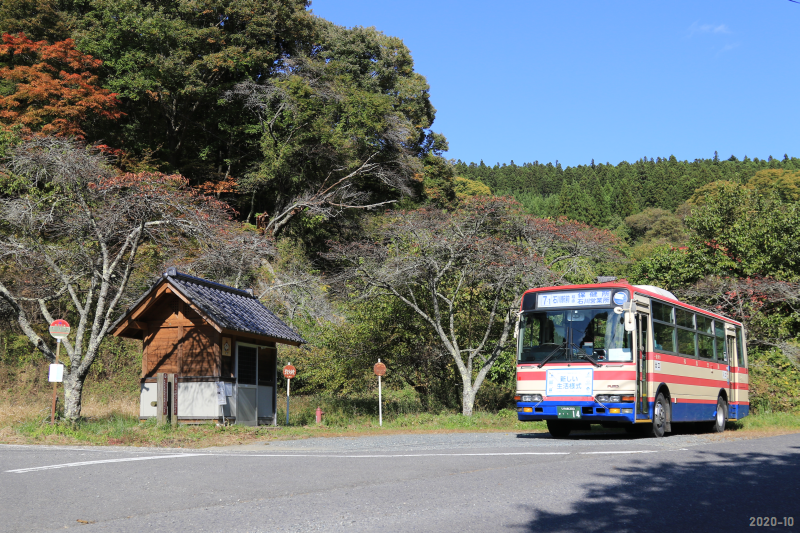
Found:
515,281 -> 750,438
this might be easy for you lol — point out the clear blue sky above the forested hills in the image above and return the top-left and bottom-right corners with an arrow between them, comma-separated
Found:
311,0 -> 800,166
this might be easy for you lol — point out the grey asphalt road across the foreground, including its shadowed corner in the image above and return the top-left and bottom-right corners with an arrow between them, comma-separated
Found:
0,433 -> 800,533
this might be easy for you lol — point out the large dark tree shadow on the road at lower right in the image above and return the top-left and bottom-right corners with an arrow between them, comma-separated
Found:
516,442 -> 800,533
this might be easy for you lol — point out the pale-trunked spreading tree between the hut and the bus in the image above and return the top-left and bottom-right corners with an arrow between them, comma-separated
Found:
326,197 -> 613,416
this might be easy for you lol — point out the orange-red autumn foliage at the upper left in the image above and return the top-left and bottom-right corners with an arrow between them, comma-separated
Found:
0,33 -> 123,139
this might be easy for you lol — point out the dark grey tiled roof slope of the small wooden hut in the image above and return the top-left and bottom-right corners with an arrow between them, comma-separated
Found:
164,268 -> 306,343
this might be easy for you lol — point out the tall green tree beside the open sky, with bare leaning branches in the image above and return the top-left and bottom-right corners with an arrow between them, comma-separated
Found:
231,21 -> 444,234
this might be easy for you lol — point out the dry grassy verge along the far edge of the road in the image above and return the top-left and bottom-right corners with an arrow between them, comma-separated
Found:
0,397 -> 800,448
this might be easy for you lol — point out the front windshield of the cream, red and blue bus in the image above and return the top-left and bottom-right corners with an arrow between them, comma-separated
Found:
517,309 -> 633,362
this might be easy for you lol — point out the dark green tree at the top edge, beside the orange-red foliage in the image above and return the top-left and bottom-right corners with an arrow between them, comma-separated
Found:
74,0 -> 315,180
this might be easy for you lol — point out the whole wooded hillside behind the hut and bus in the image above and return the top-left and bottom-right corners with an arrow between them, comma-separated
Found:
0,0 -> 800,417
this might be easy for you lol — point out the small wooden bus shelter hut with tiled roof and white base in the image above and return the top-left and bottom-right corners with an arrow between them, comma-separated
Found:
111,268 -> 305,425
